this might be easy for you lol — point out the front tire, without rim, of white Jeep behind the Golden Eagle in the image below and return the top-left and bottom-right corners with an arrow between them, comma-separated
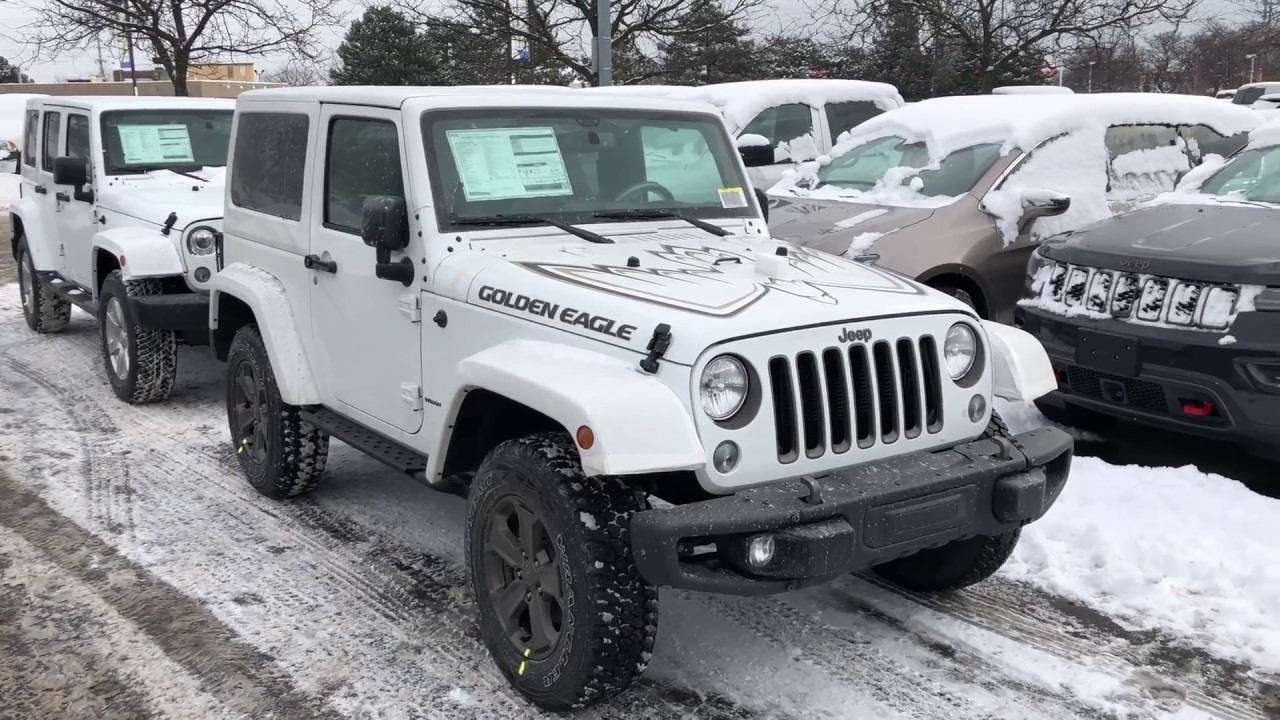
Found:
97,270 -> 178,405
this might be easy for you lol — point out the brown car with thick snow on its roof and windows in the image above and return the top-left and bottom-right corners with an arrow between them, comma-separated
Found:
768,94 -> 1262,322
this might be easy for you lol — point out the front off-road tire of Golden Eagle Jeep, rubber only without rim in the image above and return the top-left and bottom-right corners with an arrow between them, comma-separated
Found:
467,433 -> 658,711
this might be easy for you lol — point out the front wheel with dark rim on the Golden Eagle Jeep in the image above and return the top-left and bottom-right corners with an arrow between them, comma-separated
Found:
467,433 -> 658,711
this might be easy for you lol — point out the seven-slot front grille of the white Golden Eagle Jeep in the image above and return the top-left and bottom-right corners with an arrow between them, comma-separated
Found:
768,336 -> 942,462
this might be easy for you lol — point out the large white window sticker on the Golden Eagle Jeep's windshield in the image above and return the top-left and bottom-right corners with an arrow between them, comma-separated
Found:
445,127 -> 573,202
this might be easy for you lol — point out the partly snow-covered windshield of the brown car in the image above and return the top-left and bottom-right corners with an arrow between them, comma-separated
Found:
818,136 -> 1000,197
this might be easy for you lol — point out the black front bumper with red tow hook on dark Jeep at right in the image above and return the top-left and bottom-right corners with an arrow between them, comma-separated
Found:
1014,299 -> 1280,448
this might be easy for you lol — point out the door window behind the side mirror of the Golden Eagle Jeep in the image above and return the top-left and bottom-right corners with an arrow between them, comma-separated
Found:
324,118 -> 404,234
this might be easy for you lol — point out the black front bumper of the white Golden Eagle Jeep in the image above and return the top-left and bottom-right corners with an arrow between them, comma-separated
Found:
631,428 -> 1073,594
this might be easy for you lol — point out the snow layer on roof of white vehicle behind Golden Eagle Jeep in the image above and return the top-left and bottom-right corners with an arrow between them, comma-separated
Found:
589,78 -> 904,131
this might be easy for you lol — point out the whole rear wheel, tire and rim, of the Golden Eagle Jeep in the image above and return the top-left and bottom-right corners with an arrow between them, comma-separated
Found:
227,325 -> 329,500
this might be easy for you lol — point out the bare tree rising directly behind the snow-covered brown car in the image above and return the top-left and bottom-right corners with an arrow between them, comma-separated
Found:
818,0 -> 1201,90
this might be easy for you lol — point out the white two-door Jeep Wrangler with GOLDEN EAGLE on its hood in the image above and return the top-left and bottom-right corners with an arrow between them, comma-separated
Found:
210,87 -> 1073,710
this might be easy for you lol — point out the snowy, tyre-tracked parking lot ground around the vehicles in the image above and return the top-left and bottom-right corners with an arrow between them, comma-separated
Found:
0,278 -> 1280,719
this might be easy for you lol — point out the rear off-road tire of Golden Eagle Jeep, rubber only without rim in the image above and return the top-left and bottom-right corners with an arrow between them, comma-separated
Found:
227,325 -> 329,500
